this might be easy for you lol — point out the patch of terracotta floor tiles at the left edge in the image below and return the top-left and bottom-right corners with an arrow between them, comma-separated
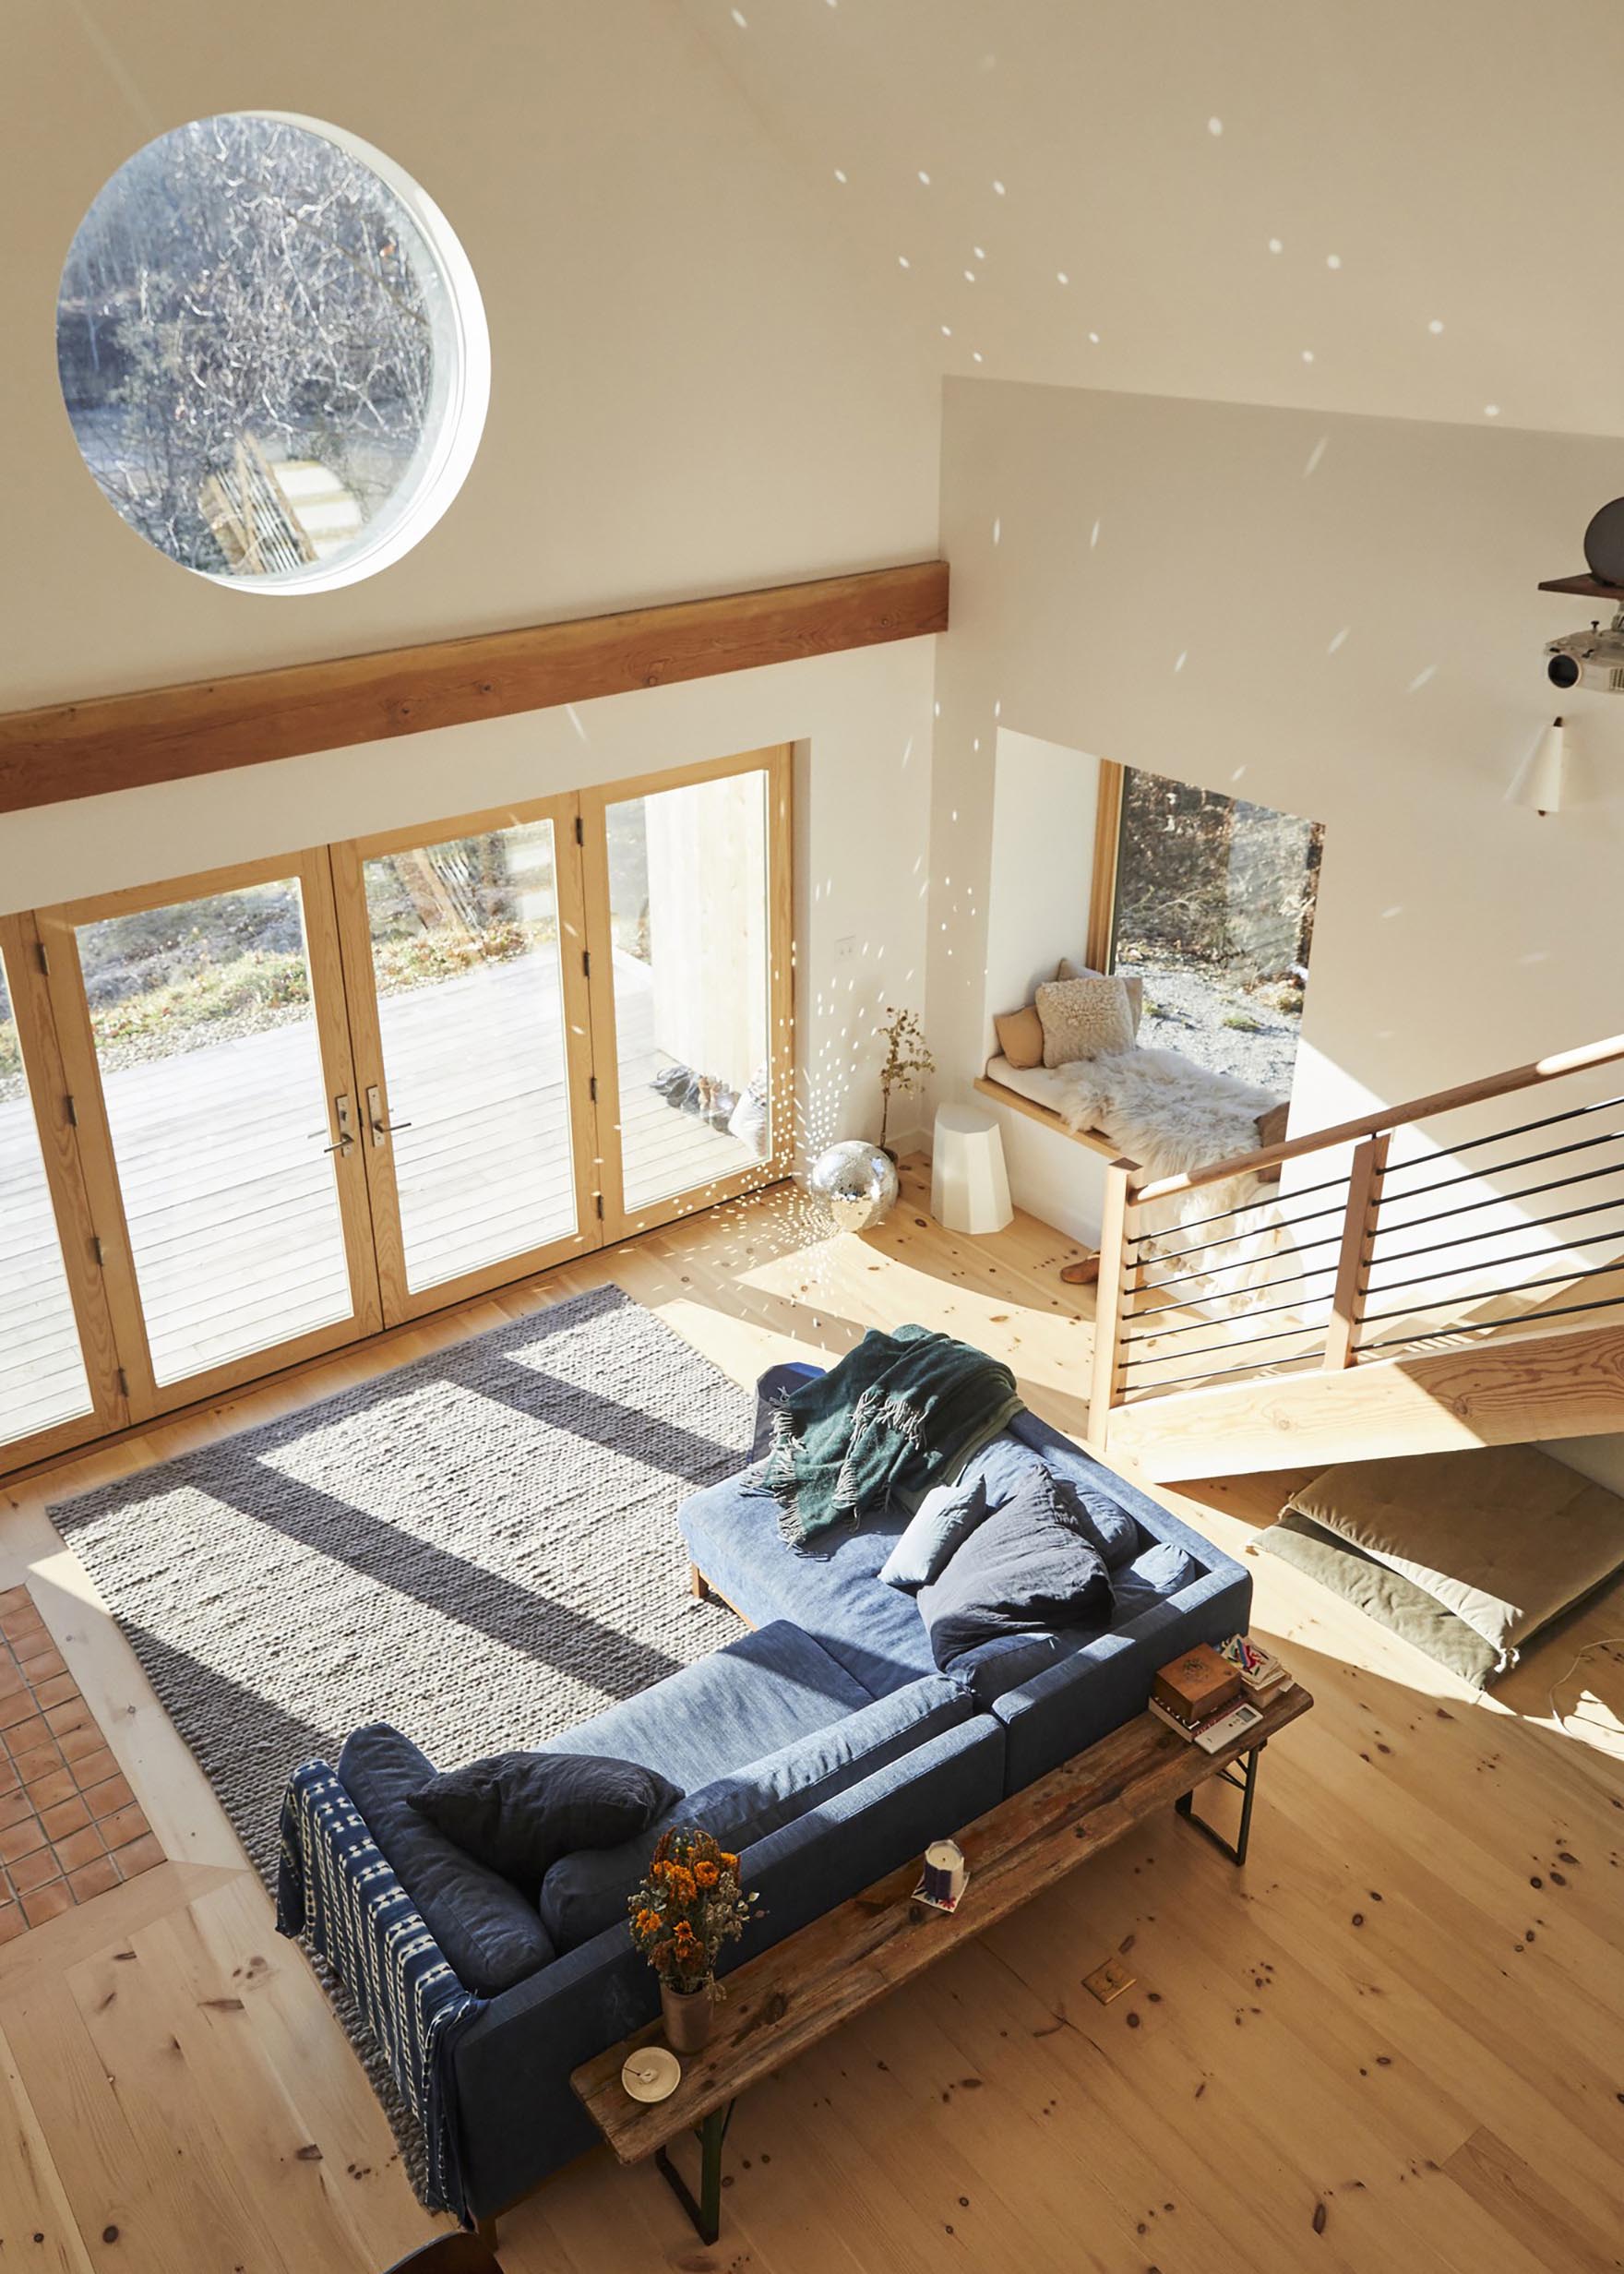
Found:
0,1587 -> 163,1942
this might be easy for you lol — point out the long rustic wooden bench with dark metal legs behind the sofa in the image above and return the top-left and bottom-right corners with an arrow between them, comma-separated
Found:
571,1682 -> 1312,2243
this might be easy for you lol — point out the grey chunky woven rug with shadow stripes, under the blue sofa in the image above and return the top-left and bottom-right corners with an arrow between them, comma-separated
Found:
50,1287 -> 753,2187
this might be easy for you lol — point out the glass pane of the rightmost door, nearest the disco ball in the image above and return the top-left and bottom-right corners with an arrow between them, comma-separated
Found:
603,771 -> 773,1219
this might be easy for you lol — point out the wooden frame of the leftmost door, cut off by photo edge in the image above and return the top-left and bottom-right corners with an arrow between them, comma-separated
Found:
0,915 -> 130,1469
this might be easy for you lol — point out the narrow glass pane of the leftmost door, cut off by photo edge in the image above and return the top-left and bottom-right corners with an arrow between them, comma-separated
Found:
0,960 -> 93,1444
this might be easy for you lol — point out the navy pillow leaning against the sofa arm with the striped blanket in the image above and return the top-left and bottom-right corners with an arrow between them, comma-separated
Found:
339,1721 -> 557,1996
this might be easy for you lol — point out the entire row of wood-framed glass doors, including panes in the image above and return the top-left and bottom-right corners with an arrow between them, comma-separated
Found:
0,750 -> 792,1471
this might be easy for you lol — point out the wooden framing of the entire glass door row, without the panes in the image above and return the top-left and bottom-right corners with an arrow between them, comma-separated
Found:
0,744 -> 794,1476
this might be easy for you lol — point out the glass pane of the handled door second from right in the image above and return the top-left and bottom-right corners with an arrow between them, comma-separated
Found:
350,819 -> 580,1294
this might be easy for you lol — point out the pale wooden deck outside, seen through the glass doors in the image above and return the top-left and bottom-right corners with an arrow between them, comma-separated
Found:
0,957 -> 753,1444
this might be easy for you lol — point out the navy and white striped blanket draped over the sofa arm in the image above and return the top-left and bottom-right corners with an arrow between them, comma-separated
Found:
275,1760 -> 484,2226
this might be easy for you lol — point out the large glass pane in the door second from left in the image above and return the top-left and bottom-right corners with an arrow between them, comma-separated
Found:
75,876 -> 355,1385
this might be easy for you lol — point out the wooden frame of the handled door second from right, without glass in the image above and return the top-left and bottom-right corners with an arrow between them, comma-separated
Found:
332,791 -> 603,1326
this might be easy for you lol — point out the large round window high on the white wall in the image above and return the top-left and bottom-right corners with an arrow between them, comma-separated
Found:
57,112 -> 489,592
